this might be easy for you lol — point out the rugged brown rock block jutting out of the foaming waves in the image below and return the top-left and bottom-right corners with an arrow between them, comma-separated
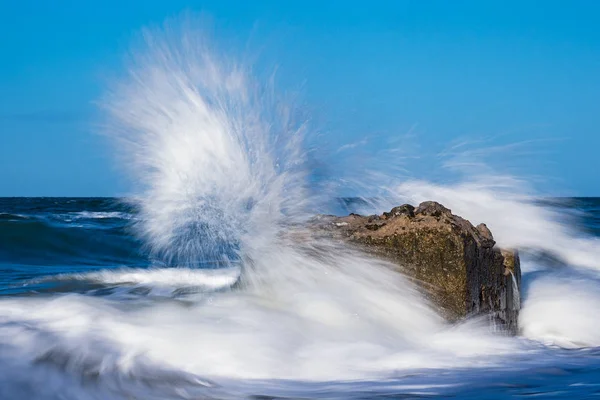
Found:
317,202 -> 521,333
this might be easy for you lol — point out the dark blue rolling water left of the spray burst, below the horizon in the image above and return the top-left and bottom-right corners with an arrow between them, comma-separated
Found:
0,198 -> 149,295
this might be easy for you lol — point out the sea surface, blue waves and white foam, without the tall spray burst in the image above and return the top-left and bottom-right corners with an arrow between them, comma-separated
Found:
0,198 -> 600,400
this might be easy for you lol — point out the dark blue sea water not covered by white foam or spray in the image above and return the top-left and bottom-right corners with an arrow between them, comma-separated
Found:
0,198 -> 600,400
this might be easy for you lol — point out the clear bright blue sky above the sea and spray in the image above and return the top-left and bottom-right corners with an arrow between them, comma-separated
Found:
0,0 -> 600,196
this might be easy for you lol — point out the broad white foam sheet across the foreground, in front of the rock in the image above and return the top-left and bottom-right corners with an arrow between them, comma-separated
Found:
0,251 -> 526,380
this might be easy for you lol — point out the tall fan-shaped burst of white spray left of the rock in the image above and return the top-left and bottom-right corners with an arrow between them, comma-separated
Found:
103,20 -> 307,265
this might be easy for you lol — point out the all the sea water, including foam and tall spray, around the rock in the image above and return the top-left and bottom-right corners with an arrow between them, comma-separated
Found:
0,21 -> 600,400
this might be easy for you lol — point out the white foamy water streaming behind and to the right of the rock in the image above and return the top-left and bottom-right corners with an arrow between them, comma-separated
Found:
396,180 -> 600,347
